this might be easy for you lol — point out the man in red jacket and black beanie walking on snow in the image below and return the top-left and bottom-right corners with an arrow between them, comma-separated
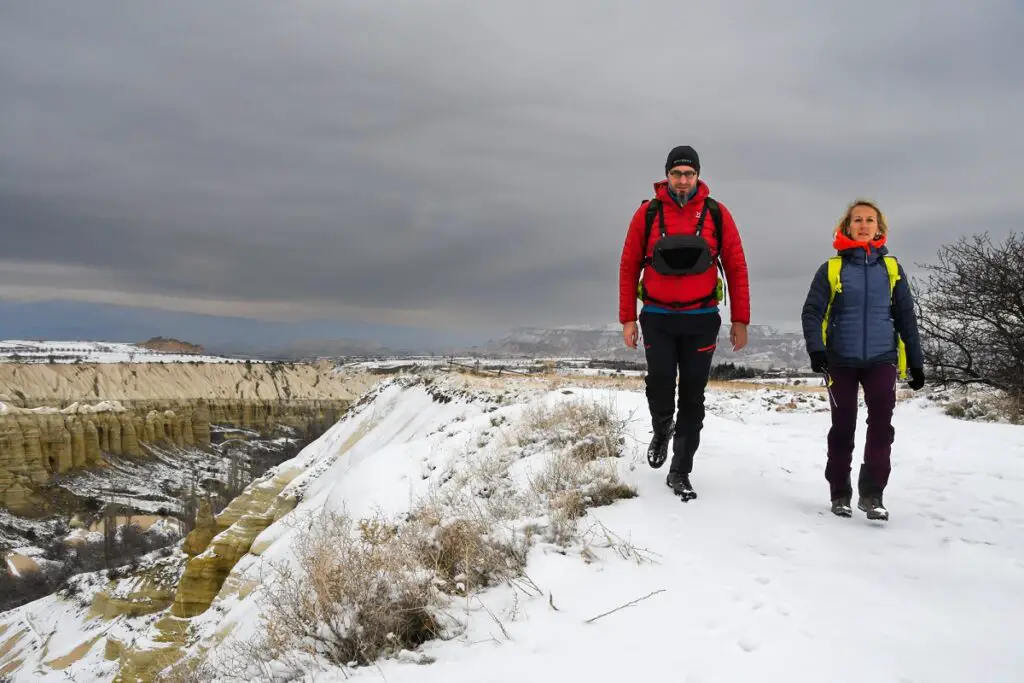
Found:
618,146 -> 751,500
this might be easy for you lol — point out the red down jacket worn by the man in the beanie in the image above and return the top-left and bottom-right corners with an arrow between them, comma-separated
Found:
618,180 -> 751,325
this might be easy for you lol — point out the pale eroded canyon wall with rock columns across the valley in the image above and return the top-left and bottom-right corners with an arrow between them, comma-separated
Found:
0,362 -> 373,515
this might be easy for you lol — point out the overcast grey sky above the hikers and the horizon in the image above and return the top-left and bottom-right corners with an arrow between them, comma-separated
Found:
0,0 -> 1024,338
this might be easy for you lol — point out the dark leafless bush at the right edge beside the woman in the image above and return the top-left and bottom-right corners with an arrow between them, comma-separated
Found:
918,229 -> 1024,413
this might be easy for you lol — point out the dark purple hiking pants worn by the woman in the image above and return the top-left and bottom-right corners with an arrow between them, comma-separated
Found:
825,364 -> 897,499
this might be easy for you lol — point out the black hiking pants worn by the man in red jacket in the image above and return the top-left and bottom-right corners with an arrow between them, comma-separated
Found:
639,311 -> 722,474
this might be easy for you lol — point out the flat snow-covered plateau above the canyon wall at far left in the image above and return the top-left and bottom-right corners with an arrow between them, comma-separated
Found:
0,339 -> 244,362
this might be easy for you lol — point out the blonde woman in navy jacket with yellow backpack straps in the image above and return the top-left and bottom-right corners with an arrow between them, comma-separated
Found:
802,200 -> 925,519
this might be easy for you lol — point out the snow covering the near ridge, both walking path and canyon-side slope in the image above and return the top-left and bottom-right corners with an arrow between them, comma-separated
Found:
0,377 -> 1024,683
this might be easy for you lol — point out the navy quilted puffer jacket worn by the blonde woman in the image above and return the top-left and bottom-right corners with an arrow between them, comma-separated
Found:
801,240 -> 925,368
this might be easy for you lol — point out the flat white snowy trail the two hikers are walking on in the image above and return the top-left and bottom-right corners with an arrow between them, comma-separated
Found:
339,394 -> 1024,683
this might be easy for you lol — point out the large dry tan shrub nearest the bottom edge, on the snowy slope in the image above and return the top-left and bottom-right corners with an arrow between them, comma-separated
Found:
253,511 -> 441,667
